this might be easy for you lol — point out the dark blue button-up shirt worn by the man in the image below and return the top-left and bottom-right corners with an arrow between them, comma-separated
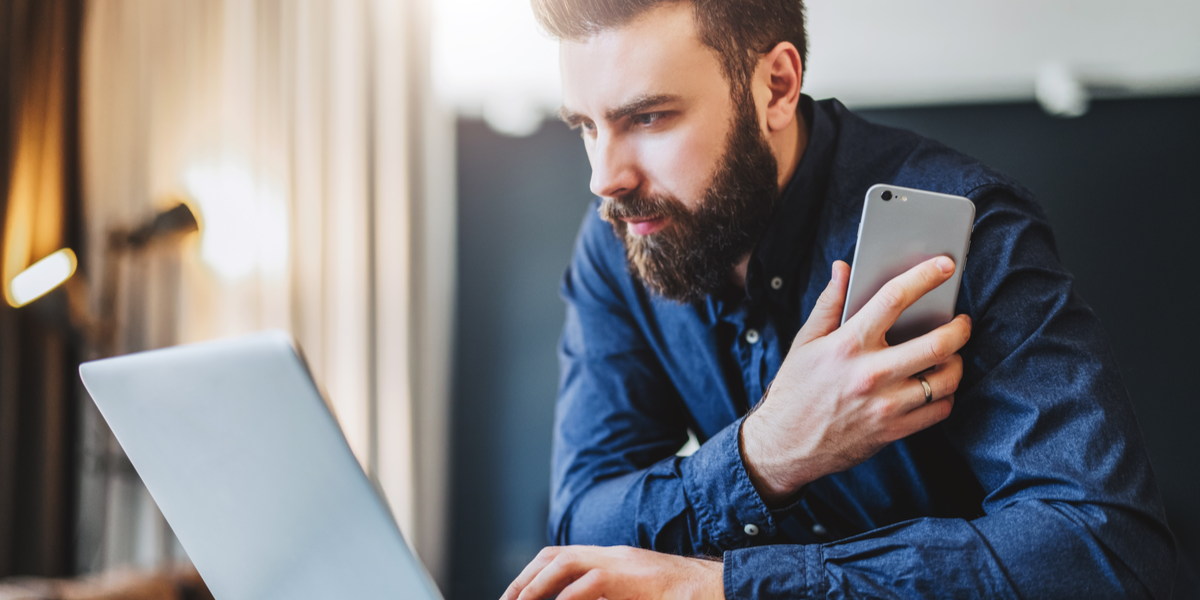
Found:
548,97 -> 1175,600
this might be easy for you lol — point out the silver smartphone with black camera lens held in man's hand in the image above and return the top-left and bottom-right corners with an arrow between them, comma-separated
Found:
841,184 -> 974,346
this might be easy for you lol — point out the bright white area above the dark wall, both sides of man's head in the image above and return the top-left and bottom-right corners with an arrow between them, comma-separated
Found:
433,0 -> 1200,133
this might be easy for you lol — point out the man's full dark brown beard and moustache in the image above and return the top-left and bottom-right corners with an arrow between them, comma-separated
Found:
600,95 -> 779,304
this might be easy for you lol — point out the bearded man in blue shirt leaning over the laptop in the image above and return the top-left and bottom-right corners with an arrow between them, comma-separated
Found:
505,0 -> 1175,600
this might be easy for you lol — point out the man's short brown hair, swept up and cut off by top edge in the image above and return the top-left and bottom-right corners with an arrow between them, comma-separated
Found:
530,0 -> 809,94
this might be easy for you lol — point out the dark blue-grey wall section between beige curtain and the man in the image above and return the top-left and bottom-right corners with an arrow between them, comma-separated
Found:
449,120 -> 592,599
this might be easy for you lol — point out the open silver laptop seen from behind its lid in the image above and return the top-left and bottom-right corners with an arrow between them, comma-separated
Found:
79,331 -> 442,600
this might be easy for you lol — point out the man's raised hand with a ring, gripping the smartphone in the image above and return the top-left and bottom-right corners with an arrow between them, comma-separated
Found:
742,257 -> 971,504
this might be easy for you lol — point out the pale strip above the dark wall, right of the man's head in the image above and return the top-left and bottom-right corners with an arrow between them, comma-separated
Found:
806,0 -> 1200,106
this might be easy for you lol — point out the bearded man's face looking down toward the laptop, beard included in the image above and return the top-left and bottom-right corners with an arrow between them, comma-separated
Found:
562,2 -> 779,301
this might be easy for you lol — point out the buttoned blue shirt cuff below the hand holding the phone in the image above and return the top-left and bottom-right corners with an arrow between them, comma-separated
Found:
680,418 -> 778,551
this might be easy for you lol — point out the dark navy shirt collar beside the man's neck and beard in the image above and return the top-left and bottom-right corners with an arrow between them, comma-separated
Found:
746,95 -> 835,304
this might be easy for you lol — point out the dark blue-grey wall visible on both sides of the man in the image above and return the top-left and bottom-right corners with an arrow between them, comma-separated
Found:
449,97 -> 1200,600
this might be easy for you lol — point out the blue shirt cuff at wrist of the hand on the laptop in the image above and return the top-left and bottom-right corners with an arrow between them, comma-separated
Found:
721,544 -> 827,600
